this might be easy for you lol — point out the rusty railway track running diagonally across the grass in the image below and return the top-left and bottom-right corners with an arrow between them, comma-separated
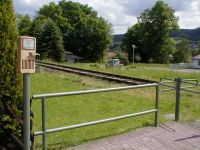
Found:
36,61 -> 156,85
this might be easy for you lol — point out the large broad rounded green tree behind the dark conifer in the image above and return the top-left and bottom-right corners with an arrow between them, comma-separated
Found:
32,0 -> 112,61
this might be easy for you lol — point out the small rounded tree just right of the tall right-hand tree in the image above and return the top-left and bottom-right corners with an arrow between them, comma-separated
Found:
173,38 -> 192,63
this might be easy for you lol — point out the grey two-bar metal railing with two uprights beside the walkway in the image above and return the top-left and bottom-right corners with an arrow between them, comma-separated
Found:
32,83 -> 159,150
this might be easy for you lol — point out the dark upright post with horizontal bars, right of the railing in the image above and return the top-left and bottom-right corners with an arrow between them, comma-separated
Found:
175,77 -> 182,121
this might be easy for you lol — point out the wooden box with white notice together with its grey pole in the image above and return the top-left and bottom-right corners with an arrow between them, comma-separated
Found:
18,36 -> 37,150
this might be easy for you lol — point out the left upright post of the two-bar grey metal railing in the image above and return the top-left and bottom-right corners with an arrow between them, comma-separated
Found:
42,97 -> 47,150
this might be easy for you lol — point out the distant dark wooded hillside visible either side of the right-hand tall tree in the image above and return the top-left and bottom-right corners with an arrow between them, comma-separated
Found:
110,28 -> 200,51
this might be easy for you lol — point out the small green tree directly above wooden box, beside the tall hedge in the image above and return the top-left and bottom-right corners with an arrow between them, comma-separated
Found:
17,15 -> 32,36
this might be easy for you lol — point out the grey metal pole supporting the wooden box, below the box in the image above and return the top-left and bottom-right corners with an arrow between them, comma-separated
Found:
23,73 -> 31,150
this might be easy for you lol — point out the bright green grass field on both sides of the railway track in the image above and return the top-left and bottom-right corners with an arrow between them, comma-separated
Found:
31,64 -> 200,149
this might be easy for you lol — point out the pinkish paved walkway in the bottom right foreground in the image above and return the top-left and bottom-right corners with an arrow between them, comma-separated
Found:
67,123 -> 200,150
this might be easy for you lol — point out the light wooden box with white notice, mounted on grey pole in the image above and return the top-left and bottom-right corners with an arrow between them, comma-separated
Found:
18,36 -> 37,73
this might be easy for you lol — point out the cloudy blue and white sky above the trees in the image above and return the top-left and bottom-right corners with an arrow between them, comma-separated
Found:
13,0 -> 200,33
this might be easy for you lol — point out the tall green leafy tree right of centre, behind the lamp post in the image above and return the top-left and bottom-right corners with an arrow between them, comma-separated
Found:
123,0 -> 179,63
